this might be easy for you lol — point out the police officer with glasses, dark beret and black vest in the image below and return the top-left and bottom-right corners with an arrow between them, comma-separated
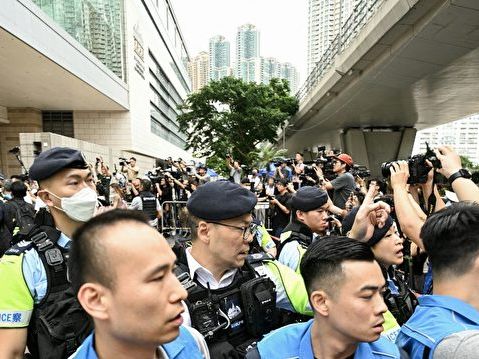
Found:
177,181 -> 311,358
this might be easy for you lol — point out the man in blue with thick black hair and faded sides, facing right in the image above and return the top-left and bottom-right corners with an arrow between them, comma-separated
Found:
247,237 -> 400,359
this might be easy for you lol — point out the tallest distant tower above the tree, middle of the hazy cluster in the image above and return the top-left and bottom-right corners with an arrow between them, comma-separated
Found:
235,24 -> 261,82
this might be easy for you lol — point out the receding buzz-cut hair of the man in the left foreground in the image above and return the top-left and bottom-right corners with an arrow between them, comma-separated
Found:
68,209 -> 149,292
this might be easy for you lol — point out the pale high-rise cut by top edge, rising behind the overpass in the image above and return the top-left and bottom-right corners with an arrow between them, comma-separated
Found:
308,0 -> 360,74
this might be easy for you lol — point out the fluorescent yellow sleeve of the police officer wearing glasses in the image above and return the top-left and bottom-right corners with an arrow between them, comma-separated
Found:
265,261 -> 313,316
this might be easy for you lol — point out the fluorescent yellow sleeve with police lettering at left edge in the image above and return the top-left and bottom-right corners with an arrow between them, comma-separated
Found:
0,253 -> 33,328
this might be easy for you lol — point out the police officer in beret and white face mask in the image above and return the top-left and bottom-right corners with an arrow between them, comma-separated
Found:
0,147 -> 97,358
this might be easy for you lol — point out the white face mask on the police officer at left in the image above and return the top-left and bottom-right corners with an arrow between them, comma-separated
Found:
50,187 -> 97,222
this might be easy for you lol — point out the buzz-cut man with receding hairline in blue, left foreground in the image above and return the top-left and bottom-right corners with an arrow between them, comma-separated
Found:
69,210 -> 209,359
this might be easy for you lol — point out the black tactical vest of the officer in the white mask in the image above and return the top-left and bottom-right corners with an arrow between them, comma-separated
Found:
5,226 -> 93,359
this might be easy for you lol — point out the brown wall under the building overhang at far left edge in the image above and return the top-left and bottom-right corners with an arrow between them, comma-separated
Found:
0,108 -> 42,176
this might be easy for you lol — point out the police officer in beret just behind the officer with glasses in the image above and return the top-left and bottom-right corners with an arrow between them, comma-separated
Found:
278,186 -> 344,273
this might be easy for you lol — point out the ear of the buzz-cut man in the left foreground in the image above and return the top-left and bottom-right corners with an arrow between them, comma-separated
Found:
77,283 -> 111,320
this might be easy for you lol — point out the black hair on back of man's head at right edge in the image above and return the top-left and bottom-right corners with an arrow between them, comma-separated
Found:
421,202 -> 479,278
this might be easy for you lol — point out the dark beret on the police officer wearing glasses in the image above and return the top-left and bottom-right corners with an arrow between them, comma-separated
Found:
186,181 -> 256,221
